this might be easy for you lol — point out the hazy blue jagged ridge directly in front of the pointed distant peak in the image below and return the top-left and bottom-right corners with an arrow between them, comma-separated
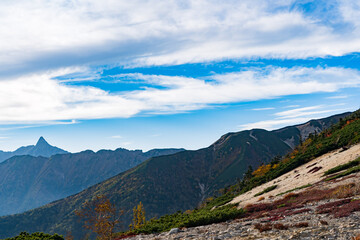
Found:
0,147 -> 183,215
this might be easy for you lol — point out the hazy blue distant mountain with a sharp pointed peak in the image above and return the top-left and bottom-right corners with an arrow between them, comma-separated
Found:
0,137 -> 68,162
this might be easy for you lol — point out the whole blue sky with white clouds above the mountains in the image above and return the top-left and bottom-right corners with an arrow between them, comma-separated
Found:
0,0 -> 360,152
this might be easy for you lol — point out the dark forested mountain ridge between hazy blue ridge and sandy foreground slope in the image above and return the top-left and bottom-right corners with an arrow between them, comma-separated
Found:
0,113 -> 349,239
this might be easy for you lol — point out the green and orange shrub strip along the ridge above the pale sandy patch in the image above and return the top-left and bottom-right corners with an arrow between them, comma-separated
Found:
210,110 -> 360,207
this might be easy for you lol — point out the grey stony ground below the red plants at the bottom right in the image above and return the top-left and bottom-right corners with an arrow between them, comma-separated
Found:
129,200 -> 360,240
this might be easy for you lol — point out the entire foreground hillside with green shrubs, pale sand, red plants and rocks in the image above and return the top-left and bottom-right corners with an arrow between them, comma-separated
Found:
120,110 -> 360,239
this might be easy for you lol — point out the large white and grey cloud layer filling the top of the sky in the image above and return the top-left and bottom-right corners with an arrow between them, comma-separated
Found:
0,0 -> 360,76
